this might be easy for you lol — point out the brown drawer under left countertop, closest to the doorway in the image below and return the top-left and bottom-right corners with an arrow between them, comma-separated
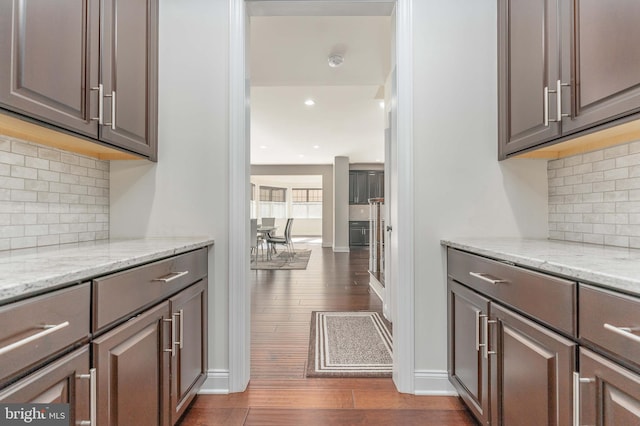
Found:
92,248 -> 207,332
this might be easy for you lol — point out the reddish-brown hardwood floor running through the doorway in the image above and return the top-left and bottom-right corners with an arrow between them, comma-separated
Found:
175,244 -> 476,426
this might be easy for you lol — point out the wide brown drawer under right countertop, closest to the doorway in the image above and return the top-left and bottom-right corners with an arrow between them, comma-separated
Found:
447,248 -> 577,336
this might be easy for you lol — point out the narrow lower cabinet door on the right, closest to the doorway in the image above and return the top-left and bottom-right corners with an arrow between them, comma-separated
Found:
448,279 -> 489,425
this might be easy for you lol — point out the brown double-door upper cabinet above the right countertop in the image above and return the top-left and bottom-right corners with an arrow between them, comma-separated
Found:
498,0 -> 640,159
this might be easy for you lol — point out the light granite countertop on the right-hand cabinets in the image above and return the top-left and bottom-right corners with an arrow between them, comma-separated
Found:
441,238 -> 640,296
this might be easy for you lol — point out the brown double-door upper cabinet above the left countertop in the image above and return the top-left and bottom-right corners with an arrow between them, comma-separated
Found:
0,0 -> 158,161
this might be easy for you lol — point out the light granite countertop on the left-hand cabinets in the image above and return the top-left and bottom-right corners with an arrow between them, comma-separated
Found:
0,237 -> 213,304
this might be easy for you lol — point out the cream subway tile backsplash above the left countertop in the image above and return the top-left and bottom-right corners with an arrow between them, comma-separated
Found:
0,135 -> 109,250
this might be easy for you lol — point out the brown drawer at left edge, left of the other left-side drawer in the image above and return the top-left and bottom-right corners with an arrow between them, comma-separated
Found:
0,283 -> 91,383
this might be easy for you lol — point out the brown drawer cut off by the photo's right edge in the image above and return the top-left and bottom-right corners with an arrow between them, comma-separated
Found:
579,284 -> 640,368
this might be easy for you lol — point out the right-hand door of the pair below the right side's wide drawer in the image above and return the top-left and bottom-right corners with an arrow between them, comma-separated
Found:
490,304 -> 575,426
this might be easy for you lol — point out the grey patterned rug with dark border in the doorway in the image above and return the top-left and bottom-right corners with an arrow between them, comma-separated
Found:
307,311 -> 393,377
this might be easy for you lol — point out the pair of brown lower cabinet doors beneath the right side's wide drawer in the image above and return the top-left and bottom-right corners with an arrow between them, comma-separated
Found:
448,279 -> 576,426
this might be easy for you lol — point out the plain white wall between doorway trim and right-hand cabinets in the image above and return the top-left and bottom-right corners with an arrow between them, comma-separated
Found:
412,0 -> 547,385
